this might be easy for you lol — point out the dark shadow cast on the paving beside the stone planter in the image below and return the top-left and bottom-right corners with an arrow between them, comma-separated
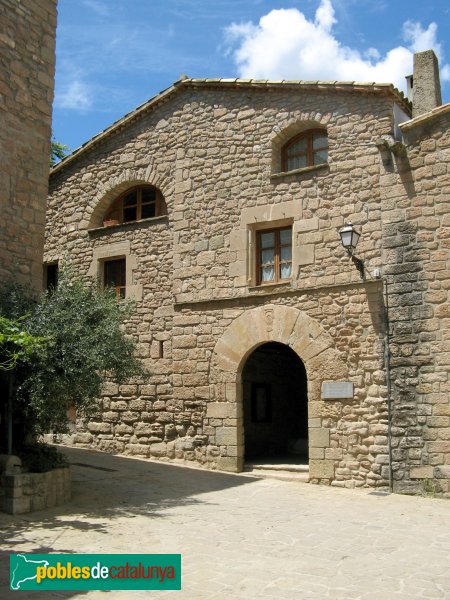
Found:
0,447 -> 259,600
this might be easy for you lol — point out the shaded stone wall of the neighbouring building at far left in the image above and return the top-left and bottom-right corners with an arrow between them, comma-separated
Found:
0,0 -> 56,289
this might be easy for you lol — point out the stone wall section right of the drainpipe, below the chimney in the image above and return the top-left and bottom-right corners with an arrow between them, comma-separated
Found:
381,106 -> 450,494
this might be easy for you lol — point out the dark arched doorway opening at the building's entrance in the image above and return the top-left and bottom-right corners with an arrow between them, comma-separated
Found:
242,342 -> 308,464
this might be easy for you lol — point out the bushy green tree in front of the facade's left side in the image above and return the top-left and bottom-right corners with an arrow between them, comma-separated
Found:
0,273 -> 145,447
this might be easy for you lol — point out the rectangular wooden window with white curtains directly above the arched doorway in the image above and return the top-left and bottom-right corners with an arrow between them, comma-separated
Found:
256,227 -> 292,285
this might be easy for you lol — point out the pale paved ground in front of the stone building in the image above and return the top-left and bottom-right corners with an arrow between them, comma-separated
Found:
0,449 -> 450,600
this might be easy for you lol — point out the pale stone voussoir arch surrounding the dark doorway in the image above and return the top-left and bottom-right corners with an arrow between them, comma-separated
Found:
211,304 -> 348,480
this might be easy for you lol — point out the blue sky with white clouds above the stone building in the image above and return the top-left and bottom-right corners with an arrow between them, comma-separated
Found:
53,0 -> 450,150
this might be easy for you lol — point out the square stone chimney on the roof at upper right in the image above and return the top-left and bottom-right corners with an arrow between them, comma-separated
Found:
407,50 -> 442,118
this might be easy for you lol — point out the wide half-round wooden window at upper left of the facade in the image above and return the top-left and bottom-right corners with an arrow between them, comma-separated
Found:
103,185 -> 166,226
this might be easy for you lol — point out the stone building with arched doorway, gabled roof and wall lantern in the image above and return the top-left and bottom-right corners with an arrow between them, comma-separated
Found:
45,52 -> 450,495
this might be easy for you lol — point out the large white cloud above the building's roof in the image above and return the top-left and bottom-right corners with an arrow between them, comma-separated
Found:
225,0 -> 450,89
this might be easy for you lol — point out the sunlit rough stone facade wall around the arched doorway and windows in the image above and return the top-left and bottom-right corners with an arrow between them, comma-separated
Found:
45,87 -> 412,487
